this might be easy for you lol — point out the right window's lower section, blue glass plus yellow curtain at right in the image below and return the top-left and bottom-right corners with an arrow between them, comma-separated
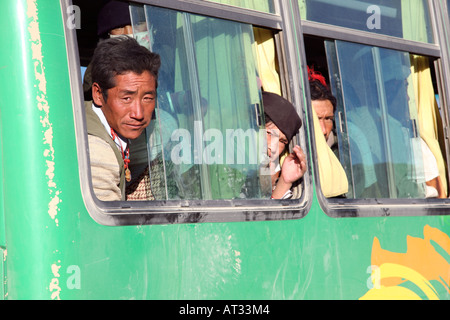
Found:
306,38 -> 447,199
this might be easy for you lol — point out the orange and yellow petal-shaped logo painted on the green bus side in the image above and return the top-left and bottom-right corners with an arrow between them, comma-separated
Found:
361,225 -> 450,300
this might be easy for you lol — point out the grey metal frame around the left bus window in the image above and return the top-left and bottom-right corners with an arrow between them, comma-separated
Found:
60,0 -> 312,226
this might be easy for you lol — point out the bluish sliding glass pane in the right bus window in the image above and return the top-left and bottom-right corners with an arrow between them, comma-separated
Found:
326,41 -> 426,198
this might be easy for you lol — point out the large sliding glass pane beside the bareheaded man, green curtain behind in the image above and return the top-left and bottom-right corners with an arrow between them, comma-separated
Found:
130,6 -> 270,200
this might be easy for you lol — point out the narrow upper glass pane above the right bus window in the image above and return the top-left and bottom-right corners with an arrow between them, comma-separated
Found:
299,0 -> 434,43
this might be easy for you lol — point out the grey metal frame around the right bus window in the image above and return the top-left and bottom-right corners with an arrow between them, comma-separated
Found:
300,0 -> 450,218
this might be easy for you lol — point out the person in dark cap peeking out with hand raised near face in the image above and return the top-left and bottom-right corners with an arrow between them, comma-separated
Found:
262,92 -> 306,199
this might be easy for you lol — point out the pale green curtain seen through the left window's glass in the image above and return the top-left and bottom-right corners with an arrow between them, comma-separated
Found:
175,15 -> 261,199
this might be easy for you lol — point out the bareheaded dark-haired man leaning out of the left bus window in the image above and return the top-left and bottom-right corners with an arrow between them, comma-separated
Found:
85,37 -> 161,201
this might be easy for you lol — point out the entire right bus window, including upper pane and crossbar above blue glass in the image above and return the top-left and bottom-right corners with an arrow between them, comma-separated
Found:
300,0 -> 448,215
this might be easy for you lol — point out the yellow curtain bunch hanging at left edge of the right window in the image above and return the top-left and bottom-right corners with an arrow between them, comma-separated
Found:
312,109 -> 348,198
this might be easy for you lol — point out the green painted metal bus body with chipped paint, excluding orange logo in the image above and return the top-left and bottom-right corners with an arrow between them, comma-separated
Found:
0,0 -> 450,299
